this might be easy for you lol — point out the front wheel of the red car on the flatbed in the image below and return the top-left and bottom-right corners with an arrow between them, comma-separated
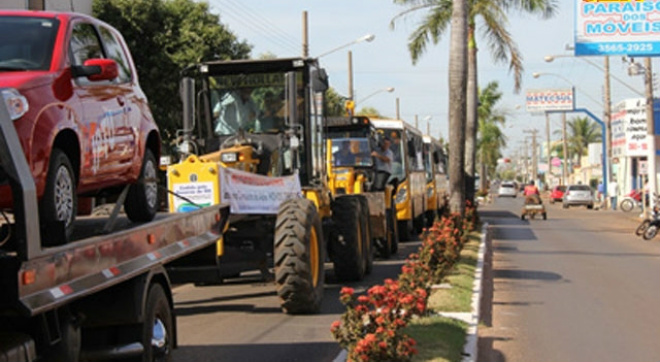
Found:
39,148 -> 78,241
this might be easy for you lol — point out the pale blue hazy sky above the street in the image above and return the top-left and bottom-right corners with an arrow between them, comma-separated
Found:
209,0 -> 656,153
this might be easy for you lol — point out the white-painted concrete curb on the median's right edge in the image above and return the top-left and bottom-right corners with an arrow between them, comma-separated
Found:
462,223 -> 488,362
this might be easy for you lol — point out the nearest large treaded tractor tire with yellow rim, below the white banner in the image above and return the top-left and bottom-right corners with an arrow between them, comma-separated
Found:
274,199 -> 325,314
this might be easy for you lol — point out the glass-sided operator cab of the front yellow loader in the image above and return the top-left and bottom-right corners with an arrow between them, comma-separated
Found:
179,58 -> 328,186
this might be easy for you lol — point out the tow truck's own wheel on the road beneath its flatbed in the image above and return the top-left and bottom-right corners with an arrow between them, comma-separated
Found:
142,283 -> 174,362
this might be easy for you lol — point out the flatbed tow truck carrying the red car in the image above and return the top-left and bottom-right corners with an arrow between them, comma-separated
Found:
0,102 -> 229,362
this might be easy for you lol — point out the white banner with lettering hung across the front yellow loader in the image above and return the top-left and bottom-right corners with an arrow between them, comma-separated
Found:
220,167 -> 302,214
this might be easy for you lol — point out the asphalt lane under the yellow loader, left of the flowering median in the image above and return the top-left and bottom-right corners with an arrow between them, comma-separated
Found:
168,236 -> 419,362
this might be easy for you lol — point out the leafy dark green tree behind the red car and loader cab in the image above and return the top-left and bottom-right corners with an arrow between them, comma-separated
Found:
92,0 -> 251,141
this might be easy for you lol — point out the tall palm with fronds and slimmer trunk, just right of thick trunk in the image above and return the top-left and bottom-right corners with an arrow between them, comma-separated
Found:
390,0 -> 557,204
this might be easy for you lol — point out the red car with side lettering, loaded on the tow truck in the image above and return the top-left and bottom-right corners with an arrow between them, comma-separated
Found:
0,10 -> 160,242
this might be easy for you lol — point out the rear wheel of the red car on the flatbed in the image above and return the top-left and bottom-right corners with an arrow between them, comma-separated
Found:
124,149 -> 158,222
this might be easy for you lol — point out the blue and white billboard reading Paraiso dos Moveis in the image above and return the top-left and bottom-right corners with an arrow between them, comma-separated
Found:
575,0 -> 660,56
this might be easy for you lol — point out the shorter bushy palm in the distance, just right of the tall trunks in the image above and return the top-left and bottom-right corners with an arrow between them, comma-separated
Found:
477,82 -> 506,190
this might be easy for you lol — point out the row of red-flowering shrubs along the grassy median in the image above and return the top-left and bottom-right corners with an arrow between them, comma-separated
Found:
330,204 -> 478,362
